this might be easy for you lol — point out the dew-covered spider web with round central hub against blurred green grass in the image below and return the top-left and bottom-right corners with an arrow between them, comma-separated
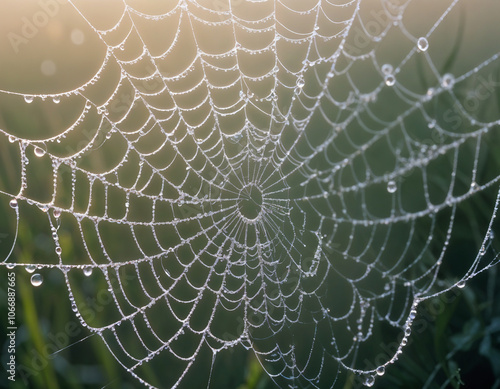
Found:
0,0 -> 500,387
